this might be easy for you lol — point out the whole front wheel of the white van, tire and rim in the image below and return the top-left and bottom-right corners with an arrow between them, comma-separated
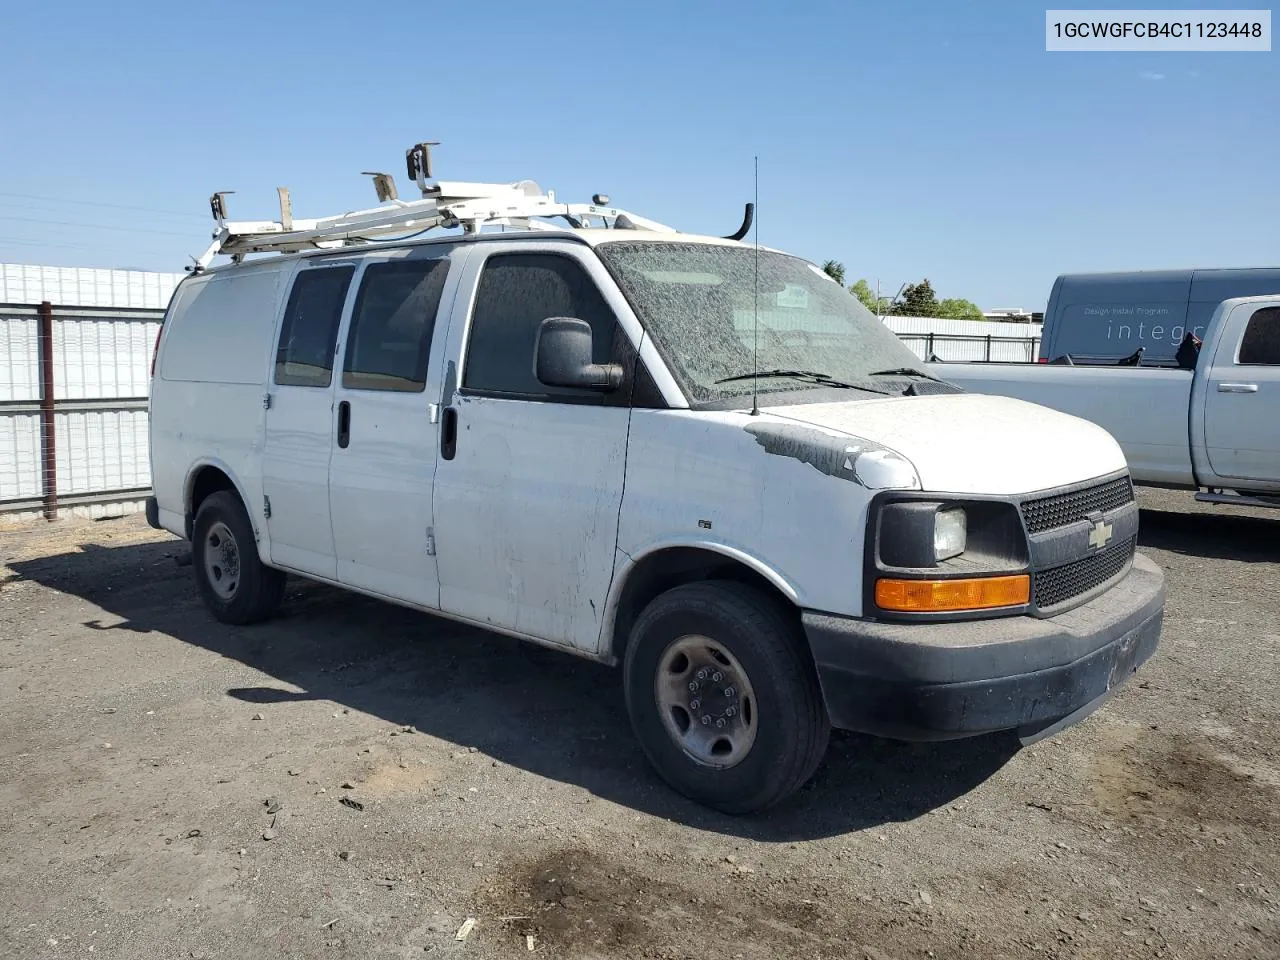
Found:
622,581 -> 831,814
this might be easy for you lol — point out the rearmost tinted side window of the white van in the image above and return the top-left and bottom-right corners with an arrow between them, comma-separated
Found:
275,266 -> 356,387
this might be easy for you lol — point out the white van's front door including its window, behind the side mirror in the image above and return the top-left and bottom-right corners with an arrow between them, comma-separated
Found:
435,248 -> 630,652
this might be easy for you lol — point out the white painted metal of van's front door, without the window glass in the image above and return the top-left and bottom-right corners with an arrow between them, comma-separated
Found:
433,239 -> 643,653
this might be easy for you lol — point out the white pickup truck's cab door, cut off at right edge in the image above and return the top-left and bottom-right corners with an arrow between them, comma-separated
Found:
1204,300 -> 1280,486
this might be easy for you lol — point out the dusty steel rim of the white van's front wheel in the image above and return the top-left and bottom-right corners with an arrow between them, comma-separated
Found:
654,635 -> 759,769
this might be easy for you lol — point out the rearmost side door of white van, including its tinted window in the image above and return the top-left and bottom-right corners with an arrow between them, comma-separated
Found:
262,264 -> 356,580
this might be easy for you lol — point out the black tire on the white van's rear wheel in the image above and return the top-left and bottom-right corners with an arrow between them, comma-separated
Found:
191,490 -> 285,625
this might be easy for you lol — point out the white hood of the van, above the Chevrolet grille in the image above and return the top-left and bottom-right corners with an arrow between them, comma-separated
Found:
753,394 -> 1126,495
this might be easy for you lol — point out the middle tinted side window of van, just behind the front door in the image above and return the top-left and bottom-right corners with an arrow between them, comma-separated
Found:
342,259 -> 449,393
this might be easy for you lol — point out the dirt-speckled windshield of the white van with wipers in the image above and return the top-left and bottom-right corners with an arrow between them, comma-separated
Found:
598,241 -> 924,402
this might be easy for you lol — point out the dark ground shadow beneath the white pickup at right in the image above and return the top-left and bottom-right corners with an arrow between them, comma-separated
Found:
1138,508 -> 1280,563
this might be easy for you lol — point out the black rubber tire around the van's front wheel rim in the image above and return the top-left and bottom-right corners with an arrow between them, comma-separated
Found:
622,581 -> 831,814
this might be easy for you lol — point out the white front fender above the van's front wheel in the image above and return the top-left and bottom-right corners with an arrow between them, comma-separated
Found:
616,410 -> 870,627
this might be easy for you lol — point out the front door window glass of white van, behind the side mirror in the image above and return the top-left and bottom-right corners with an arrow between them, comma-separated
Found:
462,253 -> 617,403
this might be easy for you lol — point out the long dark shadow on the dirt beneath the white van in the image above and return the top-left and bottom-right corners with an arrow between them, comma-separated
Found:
10,541 -> 1018,842
